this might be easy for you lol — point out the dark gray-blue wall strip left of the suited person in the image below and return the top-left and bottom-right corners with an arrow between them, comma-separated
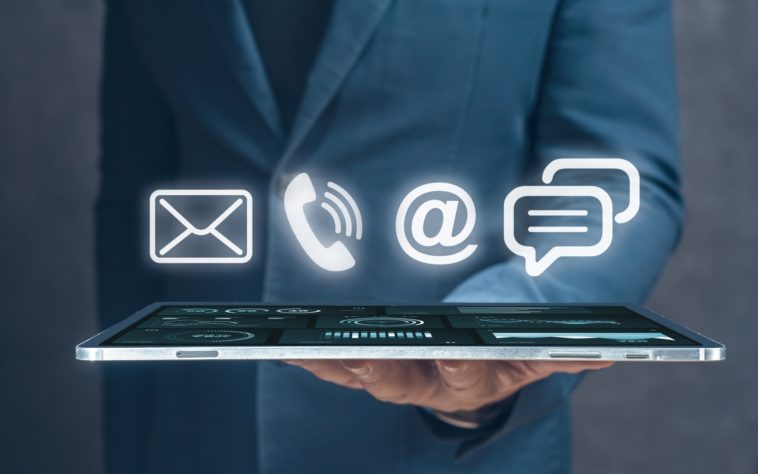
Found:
0,0 -> 103,474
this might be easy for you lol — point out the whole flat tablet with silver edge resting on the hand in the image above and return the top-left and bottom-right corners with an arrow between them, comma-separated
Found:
76,302 -> 724,362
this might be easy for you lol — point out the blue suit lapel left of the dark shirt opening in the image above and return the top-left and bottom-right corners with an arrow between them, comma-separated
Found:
203,0 -> 284,140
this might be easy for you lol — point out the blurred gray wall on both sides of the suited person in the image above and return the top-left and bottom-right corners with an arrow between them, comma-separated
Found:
0,0 -> 758,474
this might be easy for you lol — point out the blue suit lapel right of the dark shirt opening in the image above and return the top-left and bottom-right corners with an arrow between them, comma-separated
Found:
282,0 -> 392,164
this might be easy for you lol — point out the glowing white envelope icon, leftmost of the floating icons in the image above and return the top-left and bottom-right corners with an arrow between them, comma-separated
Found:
150,189 -> 253,263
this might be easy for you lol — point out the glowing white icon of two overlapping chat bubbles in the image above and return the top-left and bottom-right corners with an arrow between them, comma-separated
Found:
503,158 -> 640,276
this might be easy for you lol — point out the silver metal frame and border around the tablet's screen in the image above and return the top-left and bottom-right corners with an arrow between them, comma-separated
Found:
76,301 -> 726,362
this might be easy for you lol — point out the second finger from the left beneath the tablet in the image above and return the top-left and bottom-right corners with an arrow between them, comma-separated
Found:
342,360 -> 434,404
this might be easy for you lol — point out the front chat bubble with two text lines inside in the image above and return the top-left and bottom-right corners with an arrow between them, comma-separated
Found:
503,186 -> 613,277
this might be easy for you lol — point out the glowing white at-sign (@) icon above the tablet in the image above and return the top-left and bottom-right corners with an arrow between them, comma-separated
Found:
395,183 -> 477,265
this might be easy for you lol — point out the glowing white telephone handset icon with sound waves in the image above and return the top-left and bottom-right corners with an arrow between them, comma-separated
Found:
284,173 -> 363,272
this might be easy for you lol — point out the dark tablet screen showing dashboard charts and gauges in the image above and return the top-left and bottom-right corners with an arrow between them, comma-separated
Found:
102,305 -> 698,347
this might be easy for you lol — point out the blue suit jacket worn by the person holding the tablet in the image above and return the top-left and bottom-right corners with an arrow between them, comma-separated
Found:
97,0 -> 681,474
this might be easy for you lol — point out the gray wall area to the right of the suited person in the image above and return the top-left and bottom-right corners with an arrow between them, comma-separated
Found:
574,0 -> 758,474
